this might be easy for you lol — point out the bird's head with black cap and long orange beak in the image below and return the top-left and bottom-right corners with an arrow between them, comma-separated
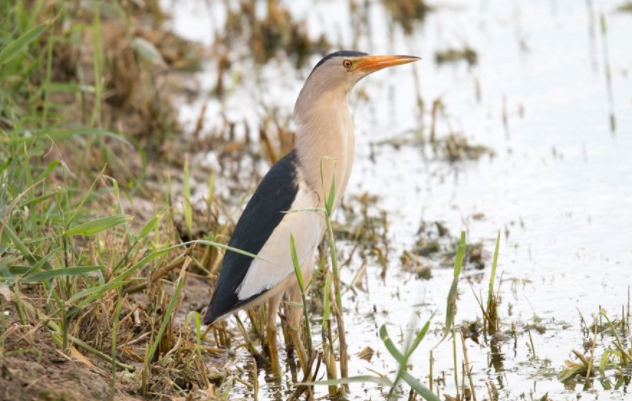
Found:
308,51 -> 419,92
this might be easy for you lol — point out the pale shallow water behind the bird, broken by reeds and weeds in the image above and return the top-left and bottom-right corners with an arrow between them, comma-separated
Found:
164,0 -> 632,400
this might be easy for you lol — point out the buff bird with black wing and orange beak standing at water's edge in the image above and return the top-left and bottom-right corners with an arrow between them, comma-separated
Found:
203,50 -> 419,371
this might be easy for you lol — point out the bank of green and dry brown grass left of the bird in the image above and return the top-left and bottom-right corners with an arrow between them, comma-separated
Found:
0,1 -> 222,400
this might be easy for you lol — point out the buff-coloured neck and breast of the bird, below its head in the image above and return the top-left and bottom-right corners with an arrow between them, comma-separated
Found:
294,91 -> 354,207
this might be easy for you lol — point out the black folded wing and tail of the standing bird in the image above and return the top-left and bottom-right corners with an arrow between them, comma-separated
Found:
204,150 -> 298,324
